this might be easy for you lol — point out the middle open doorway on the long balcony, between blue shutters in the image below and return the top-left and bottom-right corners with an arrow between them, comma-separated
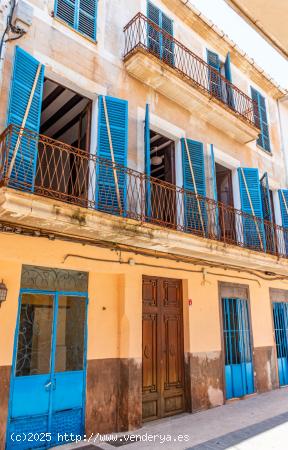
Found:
150,130 -> 176,227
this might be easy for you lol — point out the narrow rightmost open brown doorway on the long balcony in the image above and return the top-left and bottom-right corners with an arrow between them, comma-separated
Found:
215,163 -> 236,242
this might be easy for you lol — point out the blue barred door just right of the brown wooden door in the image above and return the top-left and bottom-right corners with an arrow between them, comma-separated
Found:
222,298 -> 254,399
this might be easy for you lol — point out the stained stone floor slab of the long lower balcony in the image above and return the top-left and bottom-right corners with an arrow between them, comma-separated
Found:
0,188 -> 288,276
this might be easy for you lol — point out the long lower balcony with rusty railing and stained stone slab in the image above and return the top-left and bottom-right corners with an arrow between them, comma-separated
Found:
0,125 -> 288,270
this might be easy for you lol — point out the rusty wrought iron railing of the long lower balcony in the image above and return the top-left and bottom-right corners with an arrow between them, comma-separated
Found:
0,125 -> 288,258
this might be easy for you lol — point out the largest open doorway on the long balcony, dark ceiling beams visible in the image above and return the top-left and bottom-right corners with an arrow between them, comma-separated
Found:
35,78 -> 92,206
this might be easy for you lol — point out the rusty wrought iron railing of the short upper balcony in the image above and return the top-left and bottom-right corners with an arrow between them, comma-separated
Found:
124,13 -> 260,128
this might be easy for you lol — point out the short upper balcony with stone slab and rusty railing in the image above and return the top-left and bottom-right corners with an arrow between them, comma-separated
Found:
124,13 -> 260,143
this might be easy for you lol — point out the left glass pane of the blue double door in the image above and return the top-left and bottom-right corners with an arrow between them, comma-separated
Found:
16,293 -> 54,376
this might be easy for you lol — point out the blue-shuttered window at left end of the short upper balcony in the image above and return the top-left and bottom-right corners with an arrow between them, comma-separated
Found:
147,2 -> 174,65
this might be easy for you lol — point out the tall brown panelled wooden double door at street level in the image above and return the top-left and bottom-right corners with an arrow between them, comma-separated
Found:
142,276 -> 185,421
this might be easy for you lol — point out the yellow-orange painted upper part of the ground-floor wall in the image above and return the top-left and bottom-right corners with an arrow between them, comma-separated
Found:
0,234 -> 288,365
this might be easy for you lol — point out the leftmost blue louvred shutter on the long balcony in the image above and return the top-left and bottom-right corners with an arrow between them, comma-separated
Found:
7,47 -> 44,190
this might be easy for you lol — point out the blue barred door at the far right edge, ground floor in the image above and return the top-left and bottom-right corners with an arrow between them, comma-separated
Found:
273,302 -> 288,386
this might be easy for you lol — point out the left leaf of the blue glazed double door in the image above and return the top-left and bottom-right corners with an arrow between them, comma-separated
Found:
11,294 -> 54,419
